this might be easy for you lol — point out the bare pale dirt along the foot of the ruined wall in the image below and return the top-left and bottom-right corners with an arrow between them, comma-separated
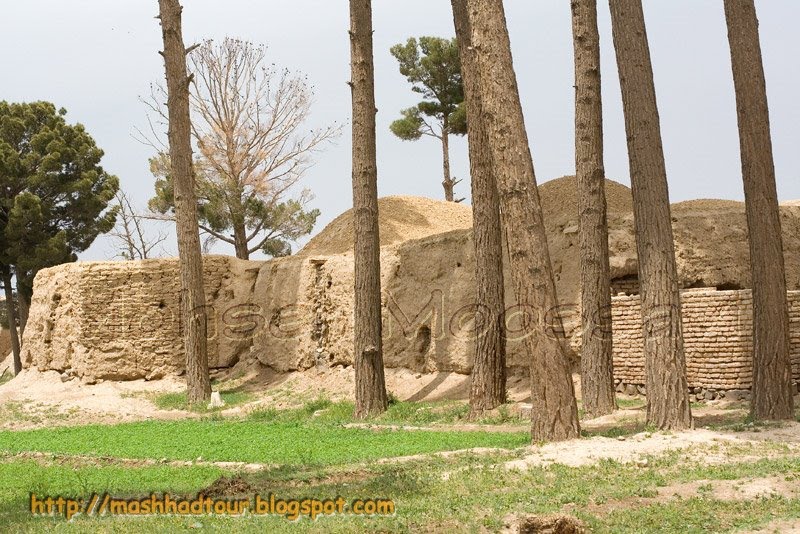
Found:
0,364 -> 529,430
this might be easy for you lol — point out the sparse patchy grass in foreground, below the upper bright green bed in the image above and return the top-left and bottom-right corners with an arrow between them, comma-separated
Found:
0,438 -> 800,533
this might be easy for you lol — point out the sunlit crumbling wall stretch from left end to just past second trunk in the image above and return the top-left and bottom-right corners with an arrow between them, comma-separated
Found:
22,251 -> 404,381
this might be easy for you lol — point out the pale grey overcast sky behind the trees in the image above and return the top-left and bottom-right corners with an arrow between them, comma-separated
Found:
0,0 -> 800,260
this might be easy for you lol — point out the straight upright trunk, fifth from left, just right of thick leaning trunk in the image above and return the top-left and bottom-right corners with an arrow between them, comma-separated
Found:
572,0 -> 617,418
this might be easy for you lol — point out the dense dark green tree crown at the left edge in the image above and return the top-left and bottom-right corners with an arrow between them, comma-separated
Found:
0,101 -> 119,300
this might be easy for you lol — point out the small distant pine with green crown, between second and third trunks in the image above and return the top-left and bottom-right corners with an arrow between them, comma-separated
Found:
389,37 -> 467,200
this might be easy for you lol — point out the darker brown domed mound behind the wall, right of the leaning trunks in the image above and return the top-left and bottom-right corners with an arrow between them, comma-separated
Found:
539,176 -> 633,221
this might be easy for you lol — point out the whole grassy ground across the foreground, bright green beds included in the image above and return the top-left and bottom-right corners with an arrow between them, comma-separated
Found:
0,400 -> 800,533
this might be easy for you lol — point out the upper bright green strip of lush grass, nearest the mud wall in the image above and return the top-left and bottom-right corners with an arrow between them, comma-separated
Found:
0,420 -> 530,465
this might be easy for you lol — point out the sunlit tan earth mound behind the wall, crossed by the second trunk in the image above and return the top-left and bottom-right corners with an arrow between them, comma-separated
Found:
298,196 -> 472,255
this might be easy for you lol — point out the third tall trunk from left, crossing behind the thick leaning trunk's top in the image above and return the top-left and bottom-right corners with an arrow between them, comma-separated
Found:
451,0 -> 506,418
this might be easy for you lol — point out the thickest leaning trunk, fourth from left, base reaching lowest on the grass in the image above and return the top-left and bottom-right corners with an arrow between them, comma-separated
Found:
467,0 -> 579,442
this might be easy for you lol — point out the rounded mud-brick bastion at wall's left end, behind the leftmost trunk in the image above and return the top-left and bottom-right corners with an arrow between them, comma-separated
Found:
22,256 -> 262,380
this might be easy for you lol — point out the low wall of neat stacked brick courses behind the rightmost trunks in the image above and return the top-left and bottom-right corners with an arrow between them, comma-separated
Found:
612,290 -> 800,390
